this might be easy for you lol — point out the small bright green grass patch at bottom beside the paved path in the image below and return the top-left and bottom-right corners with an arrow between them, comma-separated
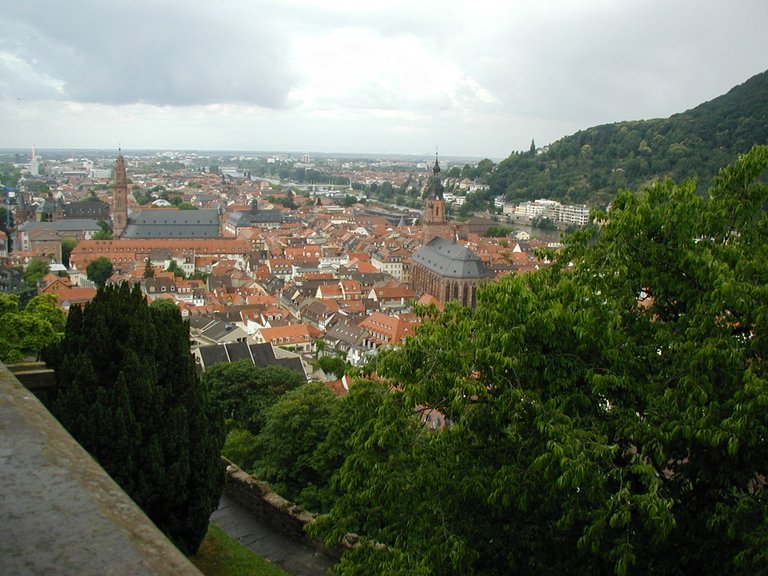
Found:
190,523 -> 289,576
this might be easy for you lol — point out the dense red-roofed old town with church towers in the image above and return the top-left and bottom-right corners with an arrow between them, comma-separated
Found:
2,148 -> 563,378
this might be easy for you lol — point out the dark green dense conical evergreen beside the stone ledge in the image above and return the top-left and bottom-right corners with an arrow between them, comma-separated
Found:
46,283 -> 224,554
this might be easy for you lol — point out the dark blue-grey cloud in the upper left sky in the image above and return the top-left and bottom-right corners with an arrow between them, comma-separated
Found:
0,2 -> 293,108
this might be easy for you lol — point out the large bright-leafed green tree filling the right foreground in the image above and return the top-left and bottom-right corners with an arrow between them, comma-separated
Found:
315,146 -> 768,576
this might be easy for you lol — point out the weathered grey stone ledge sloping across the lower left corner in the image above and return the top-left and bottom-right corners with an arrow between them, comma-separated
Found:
0,364 -> 200,576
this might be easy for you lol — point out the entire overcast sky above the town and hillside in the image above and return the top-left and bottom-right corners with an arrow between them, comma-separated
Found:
0,0 -> 768,159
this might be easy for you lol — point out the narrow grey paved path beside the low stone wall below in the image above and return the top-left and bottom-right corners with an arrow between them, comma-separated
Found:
211,494 -> 333,576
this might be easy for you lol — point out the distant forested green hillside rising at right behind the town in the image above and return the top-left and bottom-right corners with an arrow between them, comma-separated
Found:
488,72 -> 768,204
